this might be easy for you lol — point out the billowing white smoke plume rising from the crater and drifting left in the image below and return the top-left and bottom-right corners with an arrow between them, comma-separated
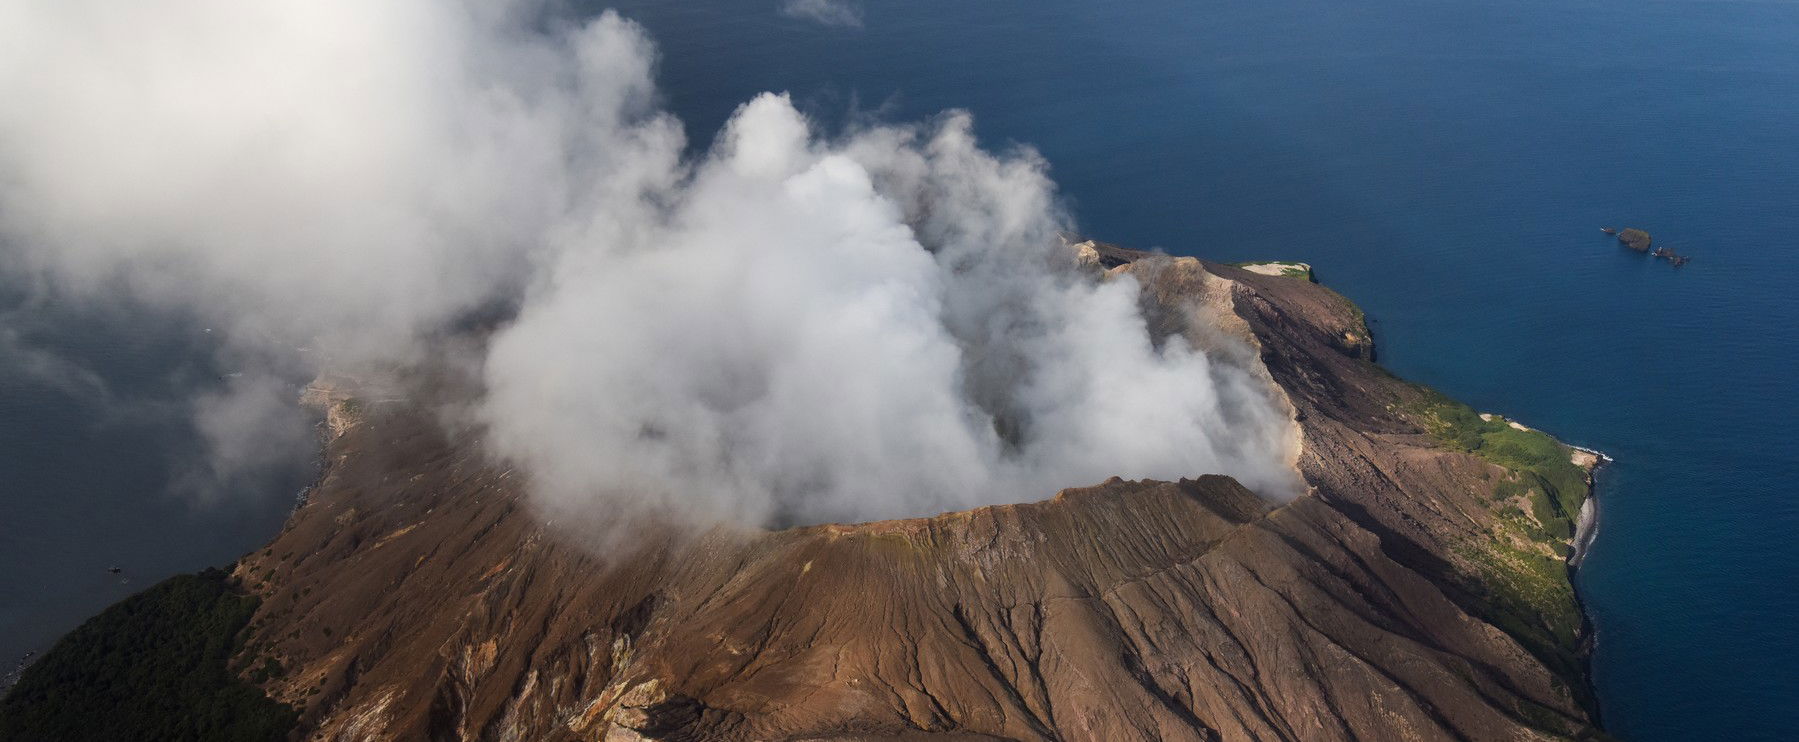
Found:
0,0 -> 1290,524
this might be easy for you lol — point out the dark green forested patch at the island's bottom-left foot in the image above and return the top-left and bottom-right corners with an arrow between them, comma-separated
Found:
0,569 -> 297,742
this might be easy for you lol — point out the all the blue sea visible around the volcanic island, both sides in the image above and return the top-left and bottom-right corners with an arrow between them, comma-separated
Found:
0,0 -> 1799,742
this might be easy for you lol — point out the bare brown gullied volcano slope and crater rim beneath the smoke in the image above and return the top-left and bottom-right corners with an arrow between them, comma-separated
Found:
236,245 -> 1594,740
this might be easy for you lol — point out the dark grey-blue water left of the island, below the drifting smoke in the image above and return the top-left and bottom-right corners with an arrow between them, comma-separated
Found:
0,300 -> 311,677
